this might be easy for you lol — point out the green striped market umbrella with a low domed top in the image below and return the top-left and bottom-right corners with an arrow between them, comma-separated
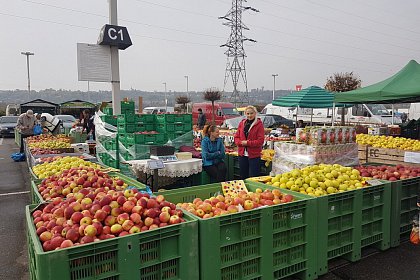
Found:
272,86 -> 349,123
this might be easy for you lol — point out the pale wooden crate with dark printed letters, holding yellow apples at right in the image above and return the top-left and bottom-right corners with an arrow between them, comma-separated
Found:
366,147 -> 420,166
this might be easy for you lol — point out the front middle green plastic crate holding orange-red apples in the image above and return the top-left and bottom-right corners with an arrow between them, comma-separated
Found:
159,183 -> 316,280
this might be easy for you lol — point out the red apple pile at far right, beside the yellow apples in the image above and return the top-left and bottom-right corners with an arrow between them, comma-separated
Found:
356,165 -> 420,181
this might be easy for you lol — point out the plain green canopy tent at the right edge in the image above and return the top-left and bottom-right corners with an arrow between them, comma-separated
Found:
334,60 -> 420,104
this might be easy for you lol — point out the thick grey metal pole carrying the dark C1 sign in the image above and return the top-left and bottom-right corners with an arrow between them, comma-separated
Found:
108,0 -> 121,115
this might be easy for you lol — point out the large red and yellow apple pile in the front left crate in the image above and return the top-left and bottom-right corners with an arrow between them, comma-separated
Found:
32,189 -> 185,251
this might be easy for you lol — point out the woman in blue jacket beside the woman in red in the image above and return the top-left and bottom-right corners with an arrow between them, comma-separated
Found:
201,125 -> 227,182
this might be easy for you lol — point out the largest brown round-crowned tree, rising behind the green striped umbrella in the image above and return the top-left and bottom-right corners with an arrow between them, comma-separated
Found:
325,72 -> 362,125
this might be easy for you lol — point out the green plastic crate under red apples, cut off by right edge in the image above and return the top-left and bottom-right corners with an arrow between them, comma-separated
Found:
391,177 -> 420,247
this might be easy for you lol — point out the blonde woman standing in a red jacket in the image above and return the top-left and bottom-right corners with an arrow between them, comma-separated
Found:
235,106 -> 264,179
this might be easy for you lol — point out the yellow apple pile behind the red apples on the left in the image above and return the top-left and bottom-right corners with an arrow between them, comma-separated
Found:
32,156 -> 101,179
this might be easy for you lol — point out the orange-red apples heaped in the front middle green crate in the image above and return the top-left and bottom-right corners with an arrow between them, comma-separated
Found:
177,188 -> 294,219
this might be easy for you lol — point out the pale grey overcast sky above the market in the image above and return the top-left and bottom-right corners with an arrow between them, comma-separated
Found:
0,0 -> 420,91
